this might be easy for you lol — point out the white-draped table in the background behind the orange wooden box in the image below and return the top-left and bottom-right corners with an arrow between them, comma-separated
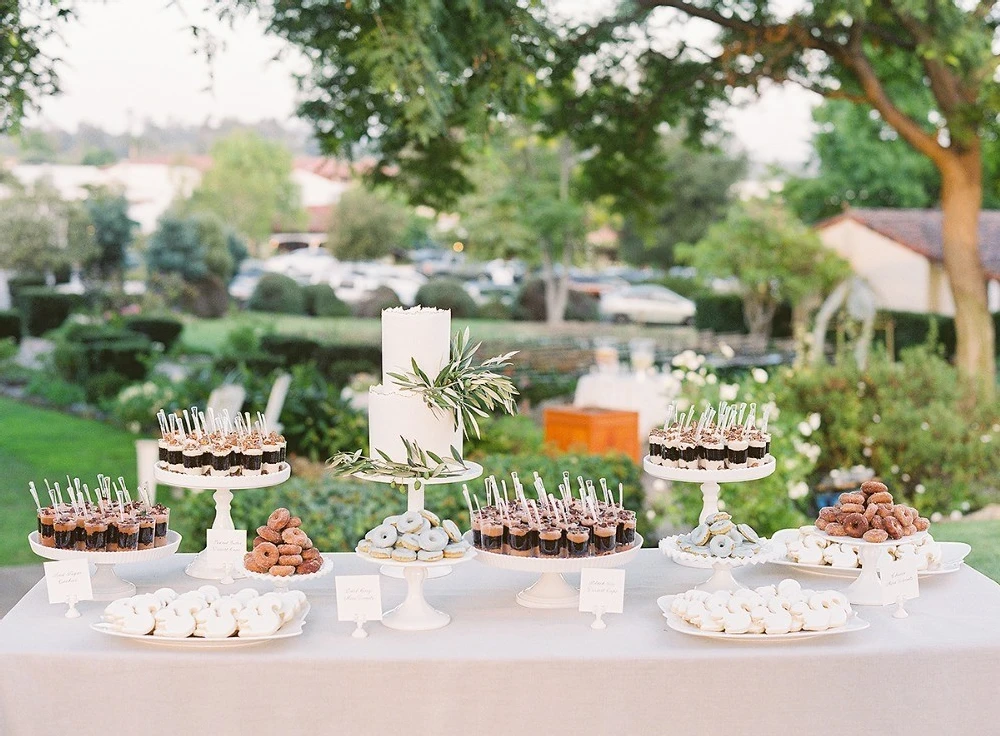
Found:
573,373 -> 677,434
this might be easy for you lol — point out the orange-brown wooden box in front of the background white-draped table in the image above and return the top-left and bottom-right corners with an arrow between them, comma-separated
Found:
545,406 -> 642,460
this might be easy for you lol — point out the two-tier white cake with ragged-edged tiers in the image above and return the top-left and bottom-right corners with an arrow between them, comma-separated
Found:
368,307 -> 462,462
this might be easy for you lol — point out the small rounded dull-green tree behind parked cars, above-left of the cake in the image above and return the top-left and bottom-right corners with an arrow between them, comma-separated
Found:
327,186 -> 413,261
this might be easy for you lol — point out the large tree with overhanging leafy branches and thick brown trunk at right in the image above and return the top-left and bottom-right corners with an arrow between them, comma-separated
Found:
229,0 -> 1000,393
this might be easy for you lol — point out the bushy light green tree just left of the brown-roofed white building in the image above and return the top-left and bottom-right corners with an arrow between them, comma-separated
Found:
677,201 -> 849,339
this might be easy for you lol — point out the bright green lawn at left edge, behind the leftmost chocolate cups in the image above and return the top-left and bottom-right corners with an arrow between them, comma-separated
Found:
0,397 -> 136,565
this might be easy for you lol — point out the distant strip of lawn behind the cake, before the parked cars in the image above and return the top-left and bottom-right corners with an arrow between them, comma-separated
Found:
181,312 -> 691,352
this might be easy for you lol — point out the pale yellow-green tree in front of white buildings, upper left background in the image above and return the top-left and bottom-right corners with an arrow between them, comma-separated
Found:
184,131 -> 305,243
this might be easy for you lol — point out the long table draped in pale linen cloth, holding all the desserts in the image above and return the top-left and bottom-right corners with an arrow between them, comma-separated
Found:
0,550 -> 1000,736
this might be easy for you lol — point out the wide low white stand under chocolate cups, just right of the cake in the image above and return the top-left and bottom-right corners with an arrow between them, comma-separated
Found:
465,532 -> 642,608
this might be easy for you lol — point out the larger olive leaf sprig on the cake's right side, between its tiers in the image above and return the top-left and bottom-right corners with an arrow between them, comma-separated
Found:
389,328 -> 517,437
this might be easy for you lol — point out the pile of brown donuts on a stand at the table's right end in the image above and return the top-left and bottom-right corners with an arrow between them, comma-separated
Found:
816,480 -> 931,544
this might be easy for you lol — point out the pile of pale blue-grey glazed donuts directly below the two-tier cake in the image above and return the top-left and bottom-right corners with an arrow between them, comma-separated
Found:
356,509 -> 469,562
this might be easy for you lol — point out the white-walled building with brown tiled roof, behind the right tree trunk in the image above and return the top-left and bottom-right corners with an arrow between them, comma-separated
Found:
816,209 -> 1000,316
